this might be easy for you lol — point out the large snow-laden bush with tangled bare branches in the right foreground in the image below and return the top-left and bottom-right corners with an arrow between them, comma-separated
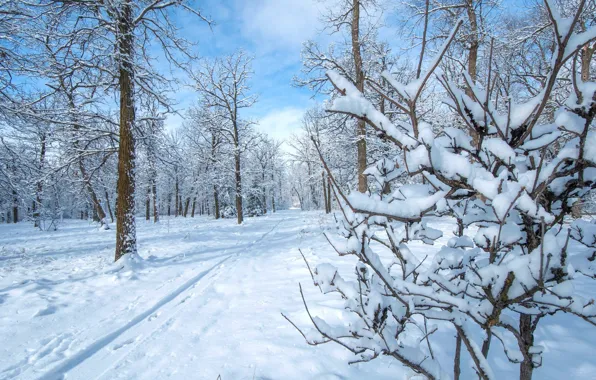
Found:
286,1 -> 596,379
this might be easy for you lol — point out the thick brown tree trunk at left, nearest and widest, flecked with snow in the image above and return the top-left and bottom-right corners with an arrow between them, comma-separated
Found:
114,1 -> 137,261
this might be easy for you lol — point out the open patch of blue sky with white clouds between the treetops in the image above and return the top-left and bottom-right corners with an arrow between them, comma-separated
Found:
166,0 -> 330,139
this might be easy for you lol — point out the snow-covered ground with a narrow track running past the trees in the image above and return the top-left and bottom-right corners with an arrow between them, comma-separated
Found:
0,210 -> 596,380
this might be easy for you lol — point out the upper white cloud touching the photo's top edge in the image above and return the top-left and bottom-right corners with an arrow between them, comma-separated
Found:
239,0 -> 320,50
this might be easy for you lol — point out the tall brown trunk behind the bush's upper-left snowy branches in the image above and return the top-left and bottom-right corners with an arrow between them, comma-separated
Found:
352,0 -> 367,193
